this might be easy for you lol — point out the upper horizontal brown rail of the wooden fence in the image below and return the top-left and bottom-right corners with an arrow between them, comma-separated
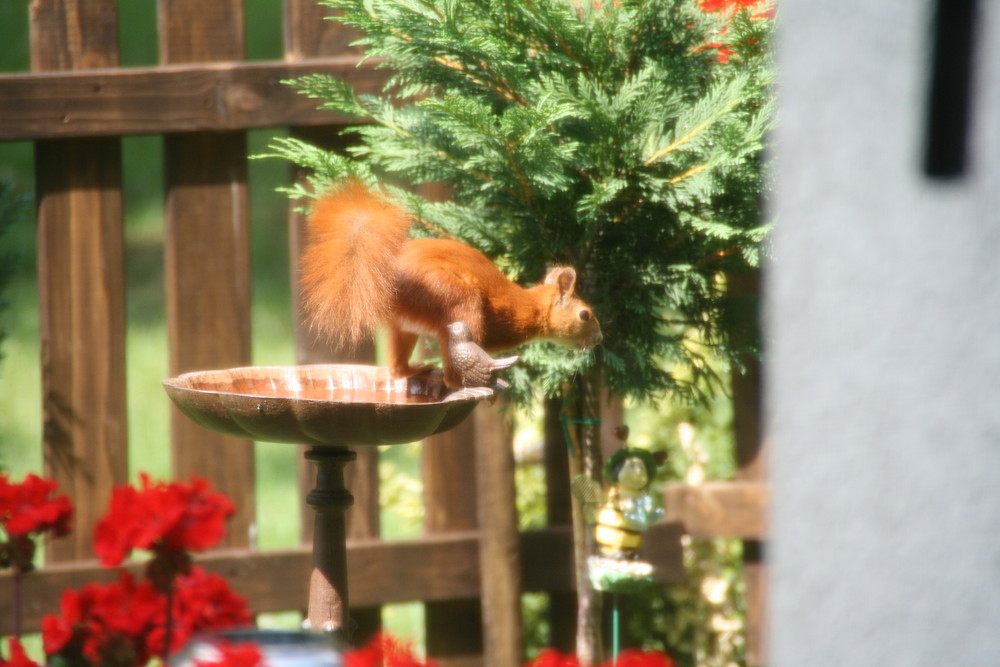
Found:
0,56 -> 387,140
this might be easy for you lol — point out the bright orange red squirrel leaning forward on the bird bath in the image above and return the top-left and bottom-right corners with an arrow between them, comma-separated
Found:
301,181 -> 602,388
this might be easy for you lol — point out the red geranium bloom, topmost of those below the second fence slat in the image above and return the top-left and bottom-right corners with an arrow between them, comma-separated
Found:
94,473 -> 234,571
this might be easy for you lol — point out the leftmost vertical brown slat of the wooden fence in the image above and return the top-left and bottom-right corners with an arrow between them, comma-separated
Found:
30,0 -> 128,561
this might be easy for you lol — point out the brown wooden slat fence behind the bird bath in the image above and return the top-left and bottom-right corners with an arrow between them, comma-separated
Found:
0,0 -> 762,667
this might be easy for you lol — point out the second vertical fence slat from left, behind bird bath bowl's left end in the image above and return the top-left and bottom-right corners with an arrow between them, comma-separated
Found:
158,0 -> 254,547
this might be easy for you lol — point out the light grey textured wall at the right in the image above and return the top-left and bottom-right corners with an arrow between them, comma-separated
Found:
766,0 -> 1000,667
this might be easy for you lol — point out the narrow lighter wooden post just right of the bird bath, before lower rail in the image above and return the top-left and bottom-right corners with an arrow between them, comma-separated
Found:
472,403 -> 524,667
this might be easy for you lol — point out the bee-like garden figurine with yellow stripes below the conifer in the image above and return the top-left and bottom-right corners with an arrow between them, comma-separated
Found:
573,434 -> 663,593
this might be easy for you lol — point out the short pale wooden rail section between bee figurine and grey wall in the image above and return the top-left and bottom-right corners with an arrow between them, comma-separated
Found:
663,481 -> 768,540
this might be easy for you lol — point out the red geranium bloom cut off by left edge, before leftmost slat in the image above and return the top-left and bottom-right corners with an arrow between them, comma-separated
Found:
0,473 -> 73,537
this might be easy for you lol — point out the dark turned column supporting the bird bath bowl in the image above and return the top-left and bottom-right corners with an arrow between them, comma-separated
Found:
305,447 -> 357,640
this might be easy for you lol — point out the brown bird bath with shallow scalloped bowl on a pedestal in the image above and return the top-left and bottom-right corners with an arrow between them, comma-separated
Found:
163,364 -> 493,634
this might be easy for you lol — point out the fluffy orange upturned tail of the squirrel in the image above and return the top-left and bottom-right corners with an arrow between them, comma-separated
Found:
301,182 -> 410,347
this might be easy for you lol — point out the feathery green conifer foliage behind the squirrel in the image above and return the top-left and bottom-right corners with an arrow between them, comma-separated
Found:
274,0 -> 772,398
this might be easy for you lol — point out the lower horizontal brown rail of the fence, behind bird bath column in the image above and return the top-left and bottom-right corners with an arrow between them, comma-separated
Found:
0,524 -> 684,632
